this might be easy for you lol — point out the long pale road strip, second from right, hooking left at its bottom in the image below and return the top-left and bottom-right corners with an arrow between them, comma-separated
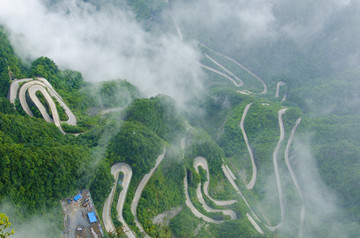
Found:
268,108 -> 287,231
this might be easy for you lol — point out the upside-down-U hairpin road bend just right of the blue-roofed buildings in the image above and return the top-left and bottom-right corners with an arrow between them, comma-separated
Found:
102,163 -> 136,238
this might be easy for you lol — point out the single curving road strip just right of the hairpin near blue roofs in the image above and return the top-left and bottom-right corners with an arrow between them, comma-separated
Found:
131,147 -> 166,237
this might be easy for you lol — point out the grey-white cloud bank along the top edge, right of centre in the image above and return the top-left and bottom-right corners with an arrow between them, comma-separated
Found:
172,0 -> 353,49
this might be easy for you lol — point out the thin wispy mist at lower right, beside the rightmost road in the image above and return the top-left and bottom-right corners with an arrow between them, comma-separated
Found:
287,135 -> 351,237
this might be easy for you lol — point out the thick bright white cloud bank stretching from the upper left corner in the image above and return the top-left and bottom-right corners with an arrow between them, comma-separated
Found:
0,0 -> 203,108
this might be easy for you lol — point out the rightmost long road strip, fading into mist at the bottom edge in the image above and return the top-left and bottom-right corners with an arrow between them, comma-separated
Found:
285,118 -> 305,237
